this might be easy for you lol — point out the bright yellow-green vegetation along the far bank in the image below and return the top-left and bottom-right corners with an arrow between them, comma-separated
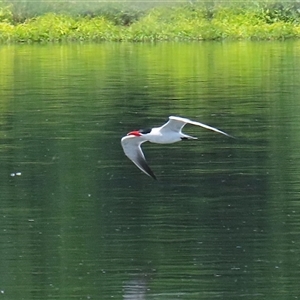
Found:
0,2 -> 300,43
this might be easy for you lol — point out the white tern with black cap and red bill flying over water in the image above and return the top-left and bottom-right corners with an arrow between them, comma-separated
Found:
121,116 -> 234,180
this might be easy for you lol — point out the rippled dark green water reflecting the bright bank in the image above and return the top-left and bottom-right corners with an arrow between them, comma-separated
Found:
0,41 -> 300,300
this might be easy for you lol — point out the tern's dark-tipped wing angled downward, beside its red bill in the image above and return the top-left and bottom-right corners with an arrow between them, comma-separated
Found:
121,135 -> 156,179
